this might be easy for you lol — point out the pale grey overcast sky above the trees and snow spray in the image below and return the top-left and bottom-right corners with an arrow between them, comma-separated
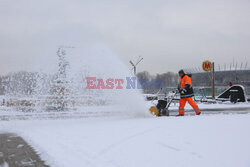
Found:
0,0 -> 250,74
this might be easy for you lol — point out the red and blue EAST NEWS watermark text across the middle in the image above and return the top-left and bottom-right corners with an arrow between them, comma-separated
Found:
86,77 -> 163,90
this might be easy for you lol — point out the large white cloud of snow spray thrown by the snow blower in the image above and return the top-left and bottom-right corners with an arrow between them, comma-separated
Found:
26,45 -> 148,117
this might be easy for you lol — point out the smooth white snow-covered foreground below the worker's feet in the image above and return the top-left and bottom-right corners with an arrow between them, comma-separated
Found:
0,114 -> 250,167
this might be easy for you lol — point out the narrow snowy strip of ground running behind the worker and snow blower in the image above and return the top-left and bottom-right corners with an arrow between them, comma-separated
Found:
0,101 -> 250,121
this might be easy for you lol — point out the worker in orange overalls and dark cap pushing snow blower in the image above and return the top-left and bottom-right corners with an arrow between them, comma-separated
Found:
178,70 -> 201,116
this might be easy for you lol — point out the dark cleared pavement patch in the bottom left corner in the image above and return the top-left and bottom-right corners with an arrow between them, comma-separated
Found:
0,133 -> 48,167
